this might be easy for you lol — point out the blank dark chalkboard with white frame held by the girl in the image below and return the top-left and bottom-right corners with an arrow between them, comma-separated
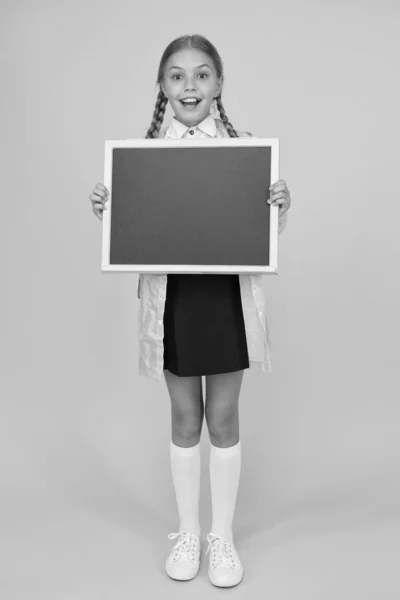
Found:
102,138 -> 279,274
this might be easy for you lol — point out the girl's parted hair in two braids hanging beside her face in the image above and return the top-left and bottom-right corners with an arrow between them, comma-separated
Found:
146,35 -> 239,139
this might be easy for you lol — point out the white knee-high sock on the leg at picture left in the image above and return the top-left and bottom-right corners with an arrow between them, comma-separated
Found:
170,440 -> 201,536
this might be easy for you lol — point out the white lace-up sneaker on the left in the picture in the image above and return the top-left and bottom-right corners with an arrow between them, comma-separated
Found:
165,531 -> 201,581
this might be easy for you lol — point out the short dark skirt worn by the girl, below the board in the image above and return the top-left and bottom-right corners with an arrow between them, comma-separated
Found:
164,274 -> 249,377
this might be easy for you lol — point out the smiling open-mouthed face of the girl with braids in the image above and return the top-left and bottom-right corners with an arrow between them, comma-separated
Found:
161,49 -> 222,127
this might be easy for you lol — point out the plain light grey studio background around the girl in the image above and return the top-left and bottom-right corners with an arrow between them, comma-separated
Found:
0,0 -> 400,600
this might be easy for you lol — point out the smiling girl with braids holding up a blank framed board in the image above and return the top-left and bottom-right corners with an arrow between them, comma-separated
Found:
90,35 -> 291,587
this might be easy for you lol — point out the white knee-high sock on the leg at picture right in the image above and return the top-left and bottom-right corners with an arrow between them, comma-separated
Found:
210,440 -> 242,541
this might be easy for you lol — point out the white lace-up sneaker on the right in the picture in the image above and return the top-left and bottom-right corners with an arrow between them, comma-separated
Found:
206,533 -> 244,587
